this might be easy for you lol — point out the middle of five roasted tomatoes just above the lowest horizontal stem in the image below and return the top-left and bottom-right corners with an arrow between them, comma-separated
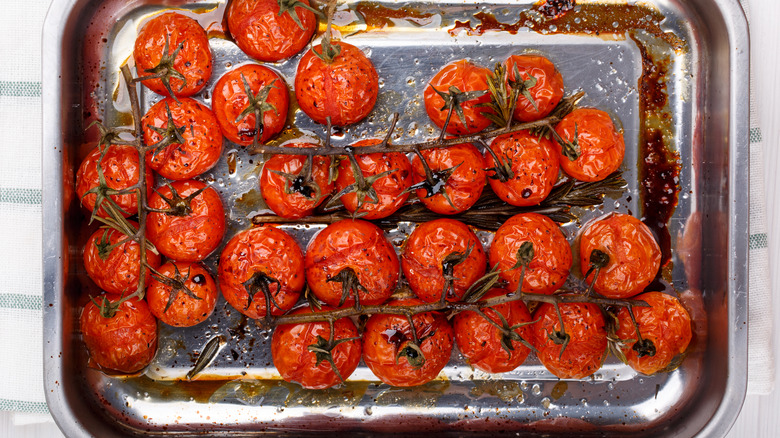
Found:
401,219 -> 486,303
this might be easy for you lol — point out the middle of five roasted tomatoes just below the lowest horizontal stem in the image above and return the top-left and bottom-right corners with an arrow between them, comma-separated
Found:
452,289 -> 533,373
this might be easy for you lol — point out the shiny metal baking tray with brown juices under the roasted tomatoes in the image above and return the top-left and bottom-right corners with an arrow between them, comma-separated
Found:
43,0 -> 749,437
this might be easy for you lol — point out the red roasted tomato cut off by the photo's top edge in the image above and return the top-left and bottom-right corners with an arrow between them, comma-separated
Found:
227,0 -> 317,62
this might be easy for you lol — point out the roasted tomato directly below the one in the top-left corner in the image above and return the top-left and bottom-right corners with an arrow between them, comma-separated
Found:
141,97 -> 222,180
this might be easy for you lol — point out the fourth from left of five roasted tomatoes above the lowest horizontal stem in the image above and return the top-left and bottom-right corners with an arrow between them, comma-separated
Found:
490,213 -> 572,295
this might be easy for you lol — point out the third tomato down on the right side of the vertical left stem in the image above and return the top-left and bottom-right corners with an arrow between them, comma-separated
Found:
146,180 -> 225,262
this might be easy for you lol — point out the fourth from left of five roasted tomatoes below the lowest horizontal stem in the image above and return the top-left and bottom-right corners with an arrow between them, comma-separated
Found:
532,303 -> 607,379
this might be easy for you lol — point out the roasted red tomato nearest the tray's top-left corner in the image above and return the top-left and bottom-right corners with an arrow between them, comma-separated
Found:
133,12 -> 212,96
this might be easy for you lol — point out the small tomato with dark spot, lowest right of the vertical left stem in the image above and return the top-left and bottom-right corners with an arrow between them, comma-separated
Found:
146,261 -> 219,327
